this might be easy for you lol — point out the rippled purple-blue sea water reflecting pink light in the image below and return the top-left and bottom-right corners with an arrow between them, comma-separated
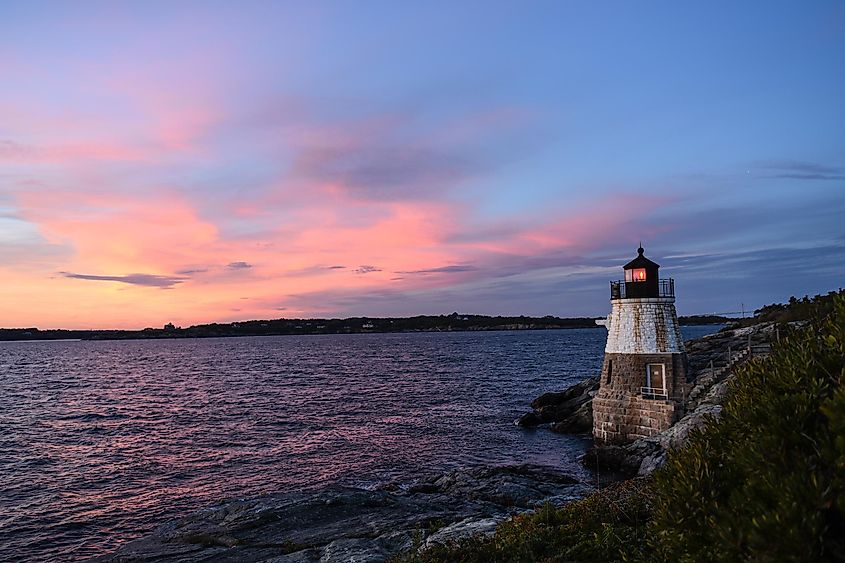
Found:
0,327 -> 717,561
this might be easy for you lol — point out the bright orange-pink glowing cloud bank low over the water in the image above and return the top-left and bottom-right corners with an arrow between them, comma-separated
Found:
3,181 -> 462,326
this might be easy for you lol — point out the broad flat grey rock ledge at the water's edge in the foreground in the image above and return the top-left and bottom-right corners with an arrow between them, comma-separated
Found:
92,465 -> 590,563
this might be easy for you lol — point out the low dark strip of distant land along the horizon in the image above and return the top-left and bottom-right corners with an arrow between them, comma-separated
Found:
0,313 -> 735,342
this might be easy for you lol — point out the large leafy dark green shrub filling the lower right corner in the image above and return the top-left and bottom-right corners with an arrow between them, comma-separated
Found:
649,296 -> 845,561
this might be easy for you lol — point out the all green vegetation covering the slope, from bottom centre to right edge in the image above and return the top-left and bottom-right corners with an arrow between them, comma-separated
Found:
401,294 -> 845,562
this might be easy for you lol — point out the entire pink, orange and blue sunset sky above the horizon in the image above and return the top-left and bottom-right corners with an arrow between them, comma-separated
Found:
0,0 -> 845,328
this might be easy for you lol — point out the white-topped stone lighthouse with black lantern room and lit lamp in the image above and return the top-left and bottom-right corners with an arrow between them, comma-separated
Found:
593,247 -> 688,443
